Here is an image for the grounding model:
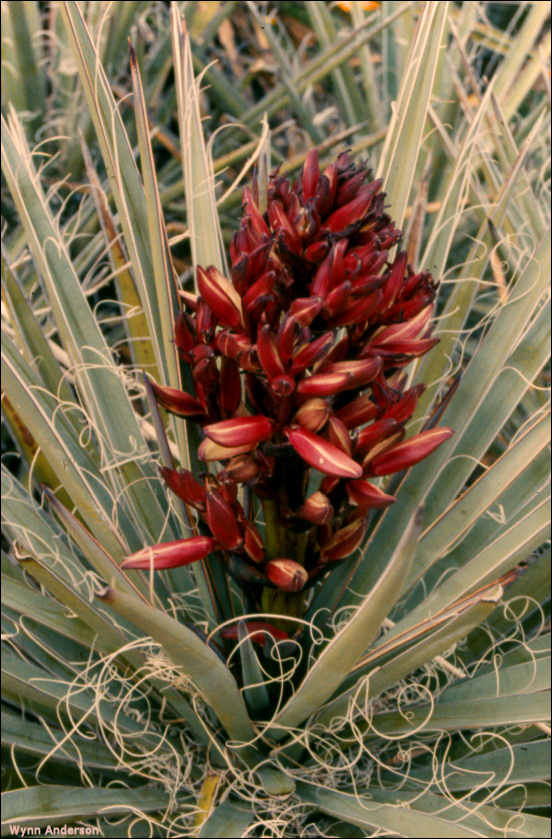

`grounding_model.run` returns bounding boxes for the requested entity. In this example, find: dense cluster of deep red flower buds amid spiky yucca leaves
[125,151,452,624]
